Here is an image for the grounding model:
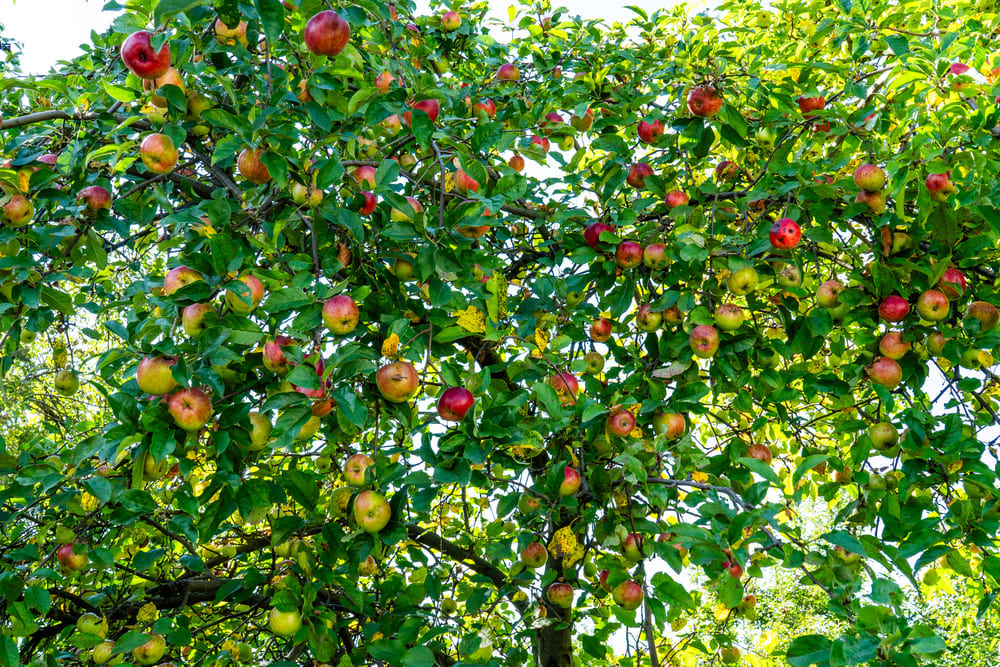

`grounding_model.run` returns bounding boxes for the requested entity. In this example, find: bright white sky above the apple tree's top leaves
[0,0,688,74]
